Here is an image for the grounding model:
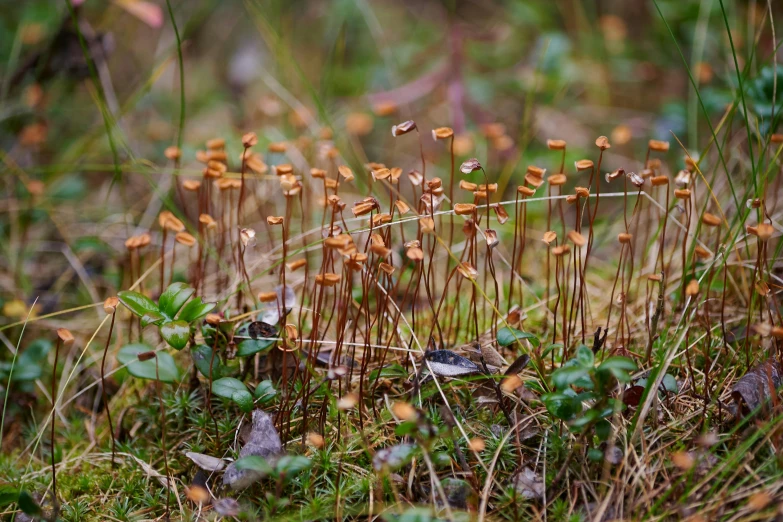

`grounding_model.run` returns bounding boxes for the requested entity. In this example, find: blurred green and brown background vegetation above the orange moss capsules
[0,0,781,312]
